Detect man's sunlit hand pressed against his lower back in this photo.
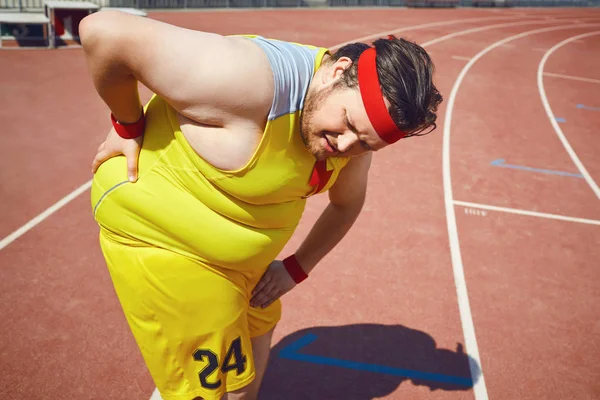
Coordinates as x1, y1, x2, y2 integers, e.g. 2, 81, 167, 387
92, 128, 144, 182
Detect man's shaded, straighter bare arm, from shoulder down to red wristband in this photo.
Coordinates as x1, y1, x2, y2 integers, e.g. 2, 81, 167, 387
296, 153, 372, 274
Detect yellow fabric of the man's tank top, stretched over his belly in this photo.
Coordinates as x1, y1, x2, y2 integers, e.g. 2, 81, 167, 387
92, 37, 348, 272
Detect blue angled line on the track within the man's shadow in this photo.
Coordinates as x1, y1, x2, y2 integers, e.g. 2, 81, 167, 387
279, 333, 473, 387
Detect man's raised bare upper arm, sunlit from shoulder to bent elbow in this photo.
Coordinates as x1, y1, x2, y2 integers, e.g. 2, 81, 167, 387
80, 11, 273, 122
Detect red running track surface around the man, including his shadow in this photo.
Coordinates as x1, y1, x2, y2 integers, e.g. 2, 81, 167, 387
0, 9, 600, 400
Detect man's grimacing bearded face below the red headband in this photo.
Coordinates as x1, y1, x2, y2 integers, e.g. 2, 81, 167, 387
300, 59, 387, 160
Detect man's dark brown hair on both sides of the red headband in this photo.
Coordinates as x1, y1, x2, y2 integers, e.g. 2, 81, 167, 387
331, 36, 443, 136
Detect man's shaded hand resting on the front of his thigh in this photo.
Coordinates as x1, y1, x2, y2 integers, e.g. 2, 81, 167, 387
250, 260, 296, 308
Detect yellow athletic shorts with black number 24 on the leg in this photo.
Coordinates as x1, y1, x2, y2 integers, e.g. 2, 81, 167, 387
100, 230, 281, 400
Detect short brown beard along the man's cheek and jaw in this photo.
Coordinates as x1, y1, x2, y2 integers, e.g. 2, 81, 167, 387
300, 87, 334, 160
